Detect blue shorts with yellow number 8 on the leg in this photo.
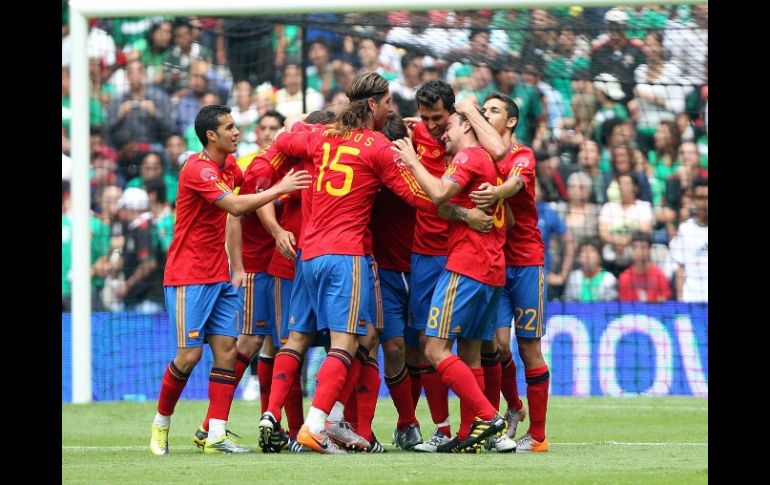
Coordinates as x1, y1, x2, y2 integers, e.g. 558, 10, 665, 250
425, 270, 503, 340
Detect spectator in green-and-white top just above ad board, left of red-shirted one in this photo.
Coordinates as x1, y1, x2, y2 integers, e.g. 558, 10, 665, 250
564, 241, 618, 302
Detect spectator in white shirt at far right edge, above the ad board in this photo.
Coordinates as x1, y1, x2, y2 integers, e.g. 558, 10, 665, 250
670, 177, 709, 302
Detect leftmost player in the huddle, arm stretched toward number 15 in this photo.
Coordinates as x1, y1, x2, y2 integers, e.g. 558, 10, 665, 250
150, 105, 311, 455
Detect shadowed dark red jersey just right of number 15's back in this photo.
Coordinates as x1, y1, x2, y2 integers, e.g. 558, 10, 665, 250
369, 187, 415, 273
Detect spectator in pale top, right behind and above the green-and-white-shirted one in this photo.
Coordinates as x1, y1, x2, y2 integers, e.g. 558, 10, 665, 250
556, 170, 600, 246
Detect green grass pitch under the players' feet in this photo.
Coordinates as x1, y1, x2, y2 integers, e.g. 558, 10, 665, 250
62, 397, 708, 485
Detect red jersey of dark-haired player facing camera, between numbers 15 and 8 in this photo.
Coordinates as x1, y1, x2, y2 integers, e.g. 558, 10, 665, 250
412, 122, 449, 255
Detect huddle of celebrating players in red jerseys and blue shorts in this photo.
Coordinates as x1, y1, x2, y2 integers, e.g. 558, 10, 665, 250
150, 73, 549, 455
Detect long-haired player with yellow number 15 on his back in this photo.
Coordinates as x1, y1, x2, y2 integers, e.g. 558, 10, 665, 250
264, 73, 476, 453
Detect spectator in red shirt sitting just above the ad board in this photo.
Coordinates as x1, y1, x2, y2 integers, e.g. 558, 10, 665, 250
618, 232, 671, 303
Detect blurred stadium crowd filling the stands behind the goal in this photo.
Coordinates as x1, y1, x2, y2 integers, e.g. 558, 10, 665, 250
62, 5, 708, 312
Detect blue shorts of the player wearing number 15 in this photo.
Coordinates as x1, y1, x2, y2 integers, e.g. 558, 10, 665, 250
304, 254, 372, 335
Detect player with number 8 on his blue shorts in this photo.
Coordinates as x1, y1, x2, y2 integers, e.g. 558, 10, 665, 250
393, 108, 505, 452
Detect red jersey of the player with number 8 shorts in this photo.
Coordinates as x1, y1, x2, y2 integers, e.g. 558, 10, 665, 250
443, 146, 505, 286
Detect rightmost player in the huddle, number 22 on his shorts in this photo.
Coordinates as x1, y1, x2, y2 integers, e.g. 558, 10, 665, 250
457, 93, 550, 453
